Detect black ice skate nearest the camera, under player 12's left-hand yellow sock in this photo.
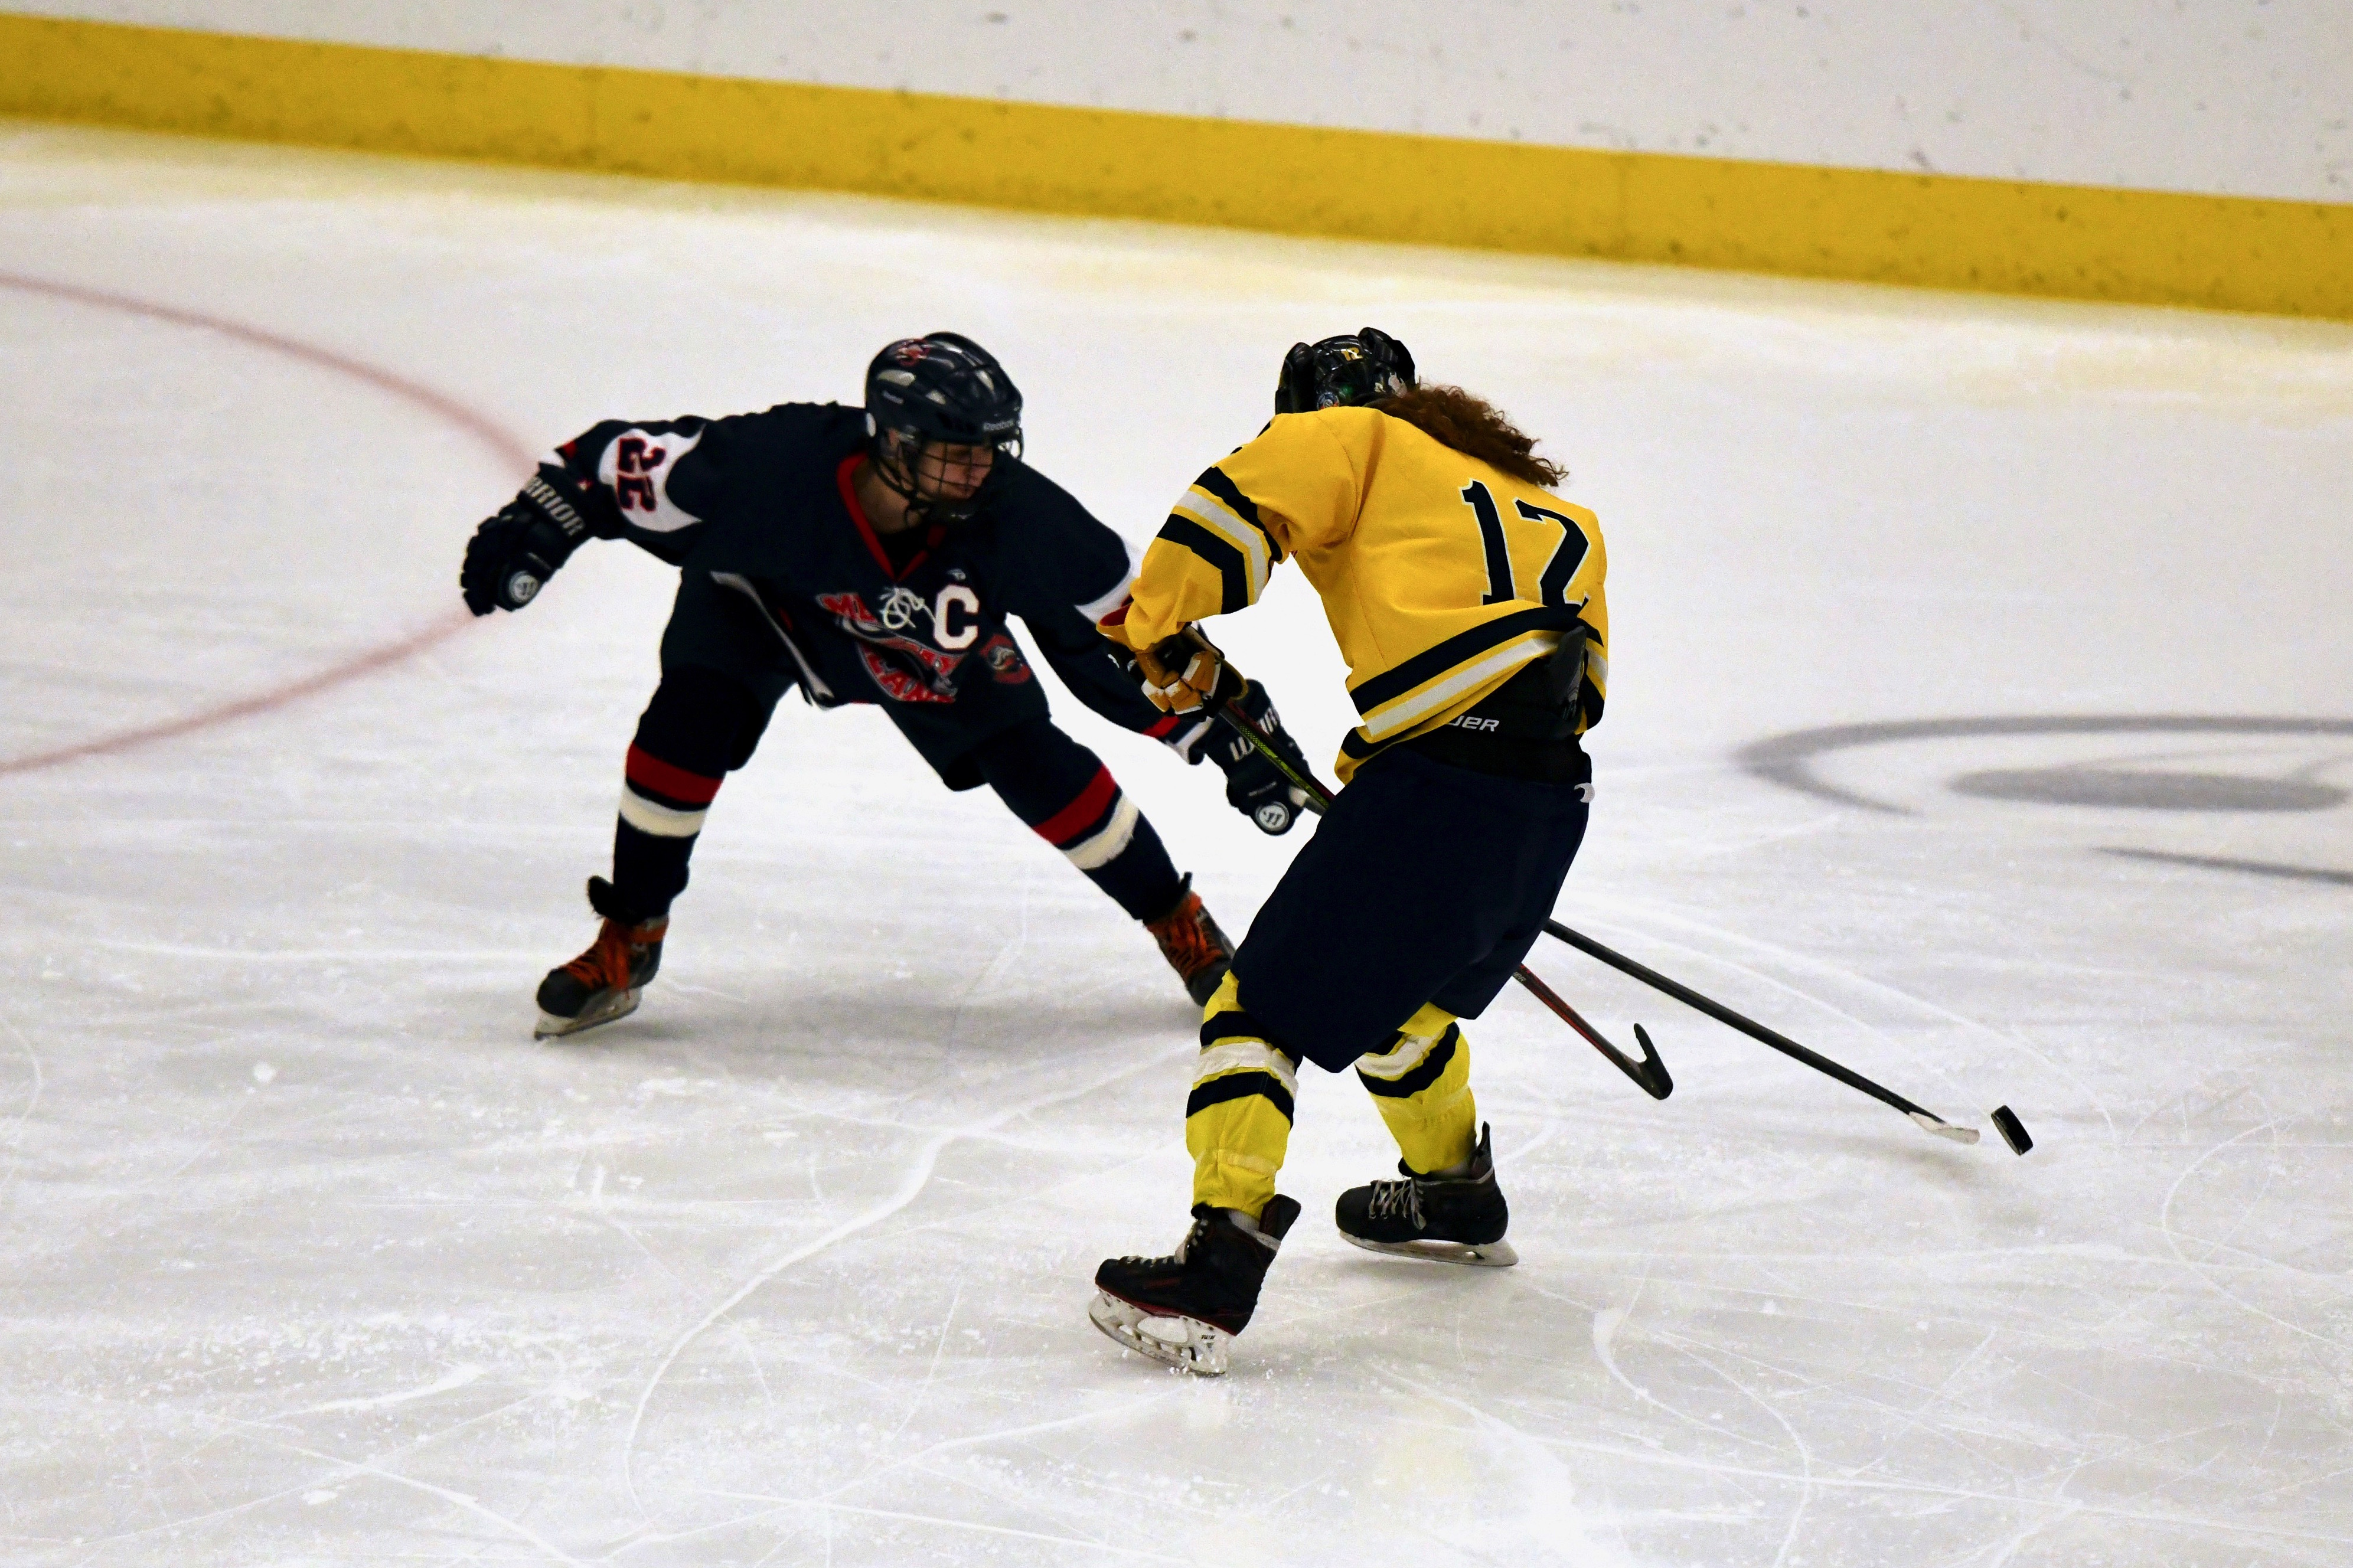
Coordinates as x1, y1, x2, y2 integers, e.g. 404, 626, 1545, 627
1087, 1196, 1299, 1377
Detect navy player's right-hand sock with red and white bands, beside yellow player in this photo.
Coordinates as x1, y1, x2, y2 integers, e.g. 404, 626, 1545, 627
972, 718, 1183, 920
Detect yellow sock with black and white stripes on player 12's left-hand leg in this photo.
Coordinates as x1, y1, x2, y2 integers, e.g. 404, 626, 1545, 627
1183, 975, 1299, 1220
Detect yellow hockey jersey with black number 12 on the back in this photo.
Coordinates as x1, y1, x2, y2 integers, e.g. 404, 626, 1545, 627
1101, 407, 1610, 782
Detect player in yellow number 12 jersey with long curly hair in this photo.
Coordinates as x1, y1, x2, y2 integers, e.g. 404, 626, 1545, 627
1089, 327, 1610, 1373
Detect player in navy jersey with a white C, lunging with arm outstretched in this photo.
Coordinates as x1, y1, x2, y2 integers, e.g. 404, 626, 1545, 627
459, 332, 1299, 1036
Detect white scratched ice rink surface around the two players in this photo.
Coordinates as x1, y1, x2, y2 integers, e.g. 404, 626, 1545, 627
0, 125, 2353, 1568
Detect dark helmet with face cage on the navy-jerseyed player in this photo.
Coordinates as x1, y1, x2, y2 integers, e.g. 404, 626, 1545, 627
866, 332, 1021, 522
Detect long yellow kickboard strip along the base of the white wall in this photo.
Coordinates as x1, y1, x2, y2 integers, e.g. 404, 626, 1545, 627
0, 17, 2353, 320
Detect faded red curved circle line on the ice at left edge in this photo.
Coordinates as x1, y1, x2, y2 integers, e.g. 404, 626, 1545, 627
0, 273, 532, 775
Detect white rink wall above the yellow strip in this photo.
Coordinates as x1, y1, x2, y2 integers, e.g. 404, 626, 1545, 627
5, 0, 2353, 202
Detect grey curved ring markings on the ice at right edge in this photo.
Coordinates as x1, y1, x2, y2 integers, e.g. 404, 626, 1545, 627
1737, 713, 2353, 885
